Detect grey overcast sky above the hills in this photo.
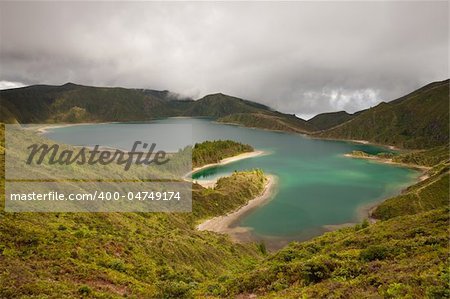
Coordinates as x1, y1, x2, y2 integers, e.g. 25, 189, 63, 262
0, 1, 449, 118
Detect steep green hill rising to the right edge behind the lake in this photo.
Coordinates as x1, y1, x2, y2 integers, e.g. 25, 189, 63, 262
316, 80, 449, 149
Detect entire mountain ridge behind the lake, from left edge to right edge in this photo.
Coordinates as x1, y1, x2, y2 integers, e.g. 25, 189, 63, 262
0, 79, 449, 149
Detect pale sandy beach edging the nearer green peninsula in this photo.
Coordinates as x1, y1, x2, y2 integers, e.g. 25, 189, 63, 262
197, 175, 277, 242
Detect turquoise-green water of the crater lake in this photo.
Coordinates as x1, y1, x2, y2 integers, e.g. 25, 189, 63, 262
46, 118, 420, 247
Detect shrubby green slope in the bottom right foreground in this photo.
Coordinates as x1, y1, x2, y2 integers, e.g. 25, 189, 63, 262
209, 208, 450, 298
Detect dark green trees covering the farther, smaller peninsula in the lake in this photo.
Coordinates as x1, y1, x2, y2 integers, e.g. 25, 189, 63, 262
192, 140, 253, 167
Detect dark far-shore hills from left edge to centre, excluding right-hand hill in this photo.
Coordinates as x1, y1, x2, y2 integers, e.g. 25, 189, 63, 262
0, 83, 313, 132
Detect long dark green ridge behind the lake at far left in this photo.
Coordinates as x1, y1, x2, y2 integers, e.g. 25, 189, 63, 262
0, 83, 172, 123
